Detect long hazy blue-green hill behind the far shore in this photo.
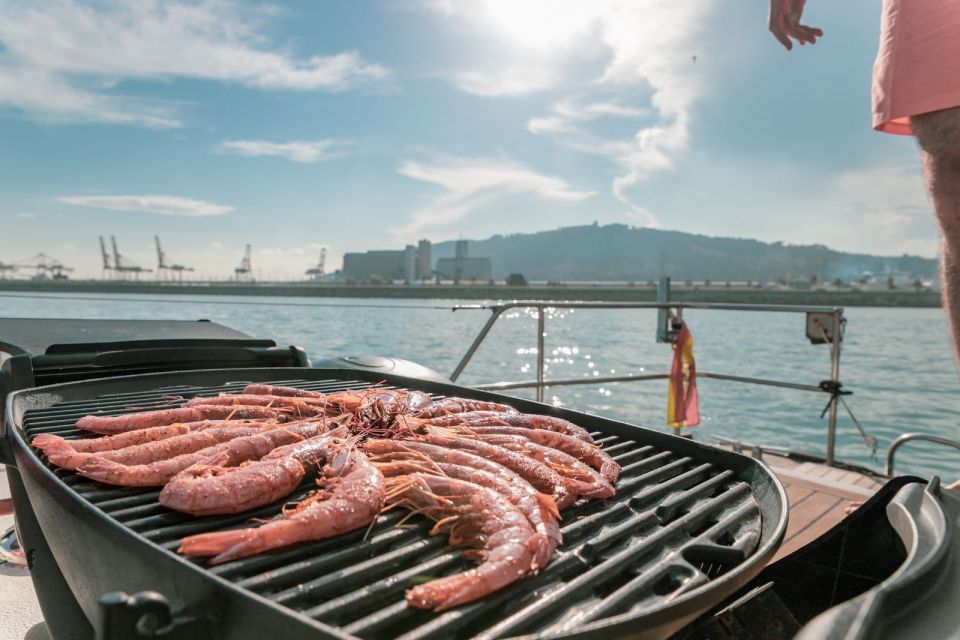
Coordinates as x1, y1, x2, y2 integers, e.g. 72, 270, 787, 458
433, 223, 937, 282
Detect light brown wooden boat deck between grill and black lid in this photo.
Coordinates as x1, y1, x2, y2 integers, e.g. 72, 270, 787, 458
763, 453, 882, 561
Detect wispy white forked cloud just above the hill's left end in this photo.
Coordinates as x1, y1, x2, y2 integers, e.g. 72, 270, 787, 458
391, 158, 595, 238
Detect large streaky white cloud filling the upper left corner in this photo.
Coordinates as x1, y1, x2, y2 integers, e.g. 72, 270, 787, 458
0, 0, 390, 127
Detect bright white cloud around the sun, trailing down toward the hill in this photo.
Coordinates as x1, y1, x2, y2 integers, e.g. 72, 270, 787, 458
432, 0, 718, 224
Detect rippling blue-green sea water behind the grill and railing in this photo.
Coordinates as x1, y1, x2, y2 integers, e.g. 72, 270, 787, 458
0, 294, 960, 481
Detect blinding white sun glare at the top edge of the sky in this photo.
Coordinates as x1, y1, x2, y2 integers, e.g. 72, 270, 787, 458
483, 0, 593, 49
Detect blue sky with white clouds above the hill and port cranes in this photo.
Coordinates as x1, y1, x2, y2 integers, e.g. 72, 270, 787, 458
0, 0, 937, 279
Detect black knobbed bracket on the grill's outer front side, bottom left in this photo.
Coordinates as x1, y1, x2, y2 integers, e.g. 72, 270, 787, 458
95, 591, 220, 640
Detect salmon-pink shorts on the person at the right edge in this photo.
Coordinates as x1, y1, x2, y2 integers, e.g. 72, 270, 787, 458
873, 0, 960, 135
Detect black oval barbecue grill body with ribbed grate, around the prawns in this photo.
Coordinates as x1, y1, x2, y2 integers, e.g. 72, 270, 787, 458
6, 369, 787, 640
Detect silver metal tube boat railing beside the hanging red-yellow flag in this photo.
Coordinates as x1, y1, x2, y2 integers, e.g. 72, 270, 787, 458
450, 300, 845, 465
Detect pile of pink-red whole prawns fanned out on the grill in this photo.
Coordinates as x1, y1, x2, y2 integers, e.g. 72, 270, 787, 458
33, 384, 620, 611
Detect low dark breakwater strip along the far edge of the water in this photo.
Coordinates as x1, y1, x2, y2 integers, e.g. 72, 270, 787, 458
0, 280, 941, 307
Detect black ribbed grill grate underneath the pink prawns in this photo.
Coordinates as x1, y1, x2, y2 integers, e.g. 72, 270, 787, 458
15, 379, 761, 640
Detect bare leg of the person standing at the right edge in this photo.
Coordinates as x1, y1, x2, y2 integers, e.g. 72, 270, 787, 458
910, 108, 960, 368
